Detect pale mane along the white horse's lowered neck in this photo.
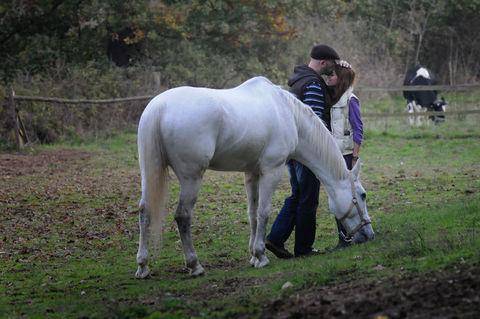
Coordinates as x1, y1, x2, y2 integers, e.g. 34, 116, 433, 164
274, 86, 348, 179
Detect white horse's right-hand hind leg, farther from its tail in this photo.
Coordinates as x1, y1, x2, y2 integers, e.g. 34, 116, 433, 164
175, 175, 205, 276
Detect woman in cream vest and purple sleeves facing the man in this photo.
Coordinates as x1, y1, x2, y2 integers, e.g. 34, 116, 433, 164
325, 64, 363, 249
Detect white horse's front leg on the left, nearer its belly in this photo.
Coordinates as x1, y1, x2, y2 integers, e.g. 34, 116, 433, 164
245, 173, 258, 266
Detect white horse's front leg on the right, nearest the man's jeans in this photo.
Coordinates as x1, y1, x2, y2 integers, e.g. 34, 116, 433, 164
253, 166, 283, 268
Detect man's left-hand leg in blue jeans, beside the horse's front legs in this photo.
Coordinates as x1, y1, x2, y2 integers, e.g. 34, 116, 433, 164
267, 161, 298, 258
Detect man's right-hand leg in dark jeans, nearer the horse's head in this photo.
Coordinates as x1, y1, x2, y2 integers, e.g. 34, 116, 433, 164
295, 163, 320, 256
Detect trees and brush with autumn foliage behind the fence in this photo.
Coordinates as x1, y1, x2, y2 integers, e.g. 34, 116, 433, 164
0, 0, 480, 146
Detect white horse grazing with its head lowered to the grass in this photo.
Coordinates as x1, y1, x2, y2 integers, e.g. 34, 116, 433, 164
136, 77, 374, 278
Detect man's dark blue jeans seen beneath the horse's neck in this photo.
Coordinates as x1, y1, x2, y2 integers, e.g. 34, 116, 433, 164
267, 160, 320, 256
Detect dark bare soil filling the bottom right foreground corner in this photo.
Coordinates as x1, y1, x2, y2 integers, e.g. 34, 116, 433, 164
261, 265, 480, 319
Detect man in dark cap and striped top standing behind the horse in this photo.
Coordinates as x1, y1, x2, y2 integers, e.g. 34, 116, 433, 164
265, 44, 340, 258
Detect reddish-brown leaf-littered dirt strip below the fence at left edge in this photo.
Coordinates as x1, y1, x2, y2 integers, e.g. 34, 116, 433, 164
0, 150, 91, 178
